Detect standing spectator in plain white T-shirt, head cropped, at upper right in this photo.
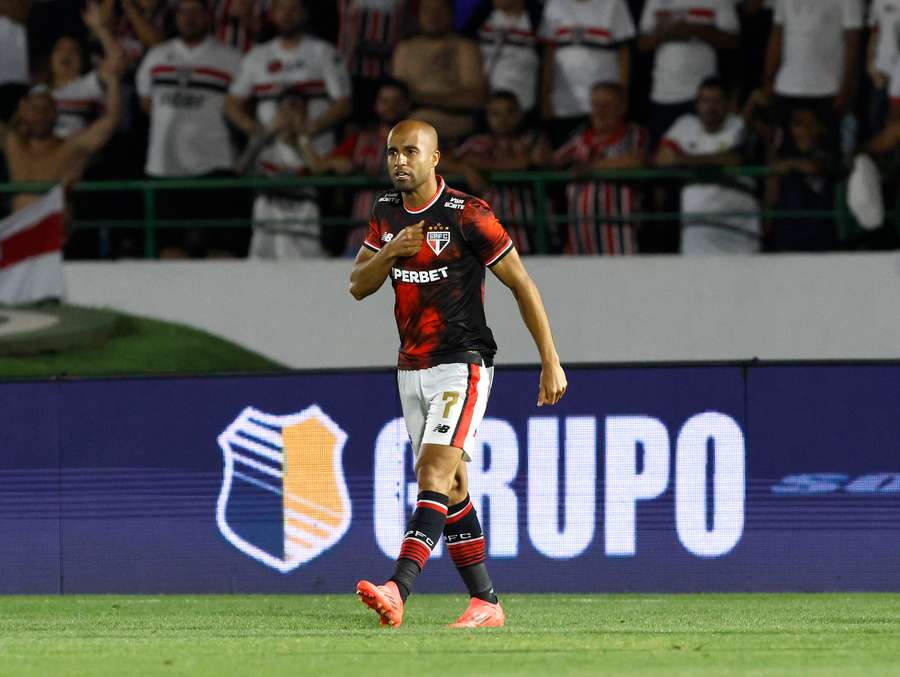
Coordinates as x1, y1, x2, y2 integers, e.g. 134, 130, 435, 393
765, 0, 863, 134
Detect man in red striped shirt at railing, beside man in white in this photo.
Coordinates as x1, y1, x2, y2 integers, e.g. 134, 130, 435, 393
554, 82, 649, 254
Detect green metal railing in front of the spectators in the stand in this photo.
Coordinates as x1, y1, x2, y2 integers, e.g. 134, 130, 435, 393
0, 166, 872, 258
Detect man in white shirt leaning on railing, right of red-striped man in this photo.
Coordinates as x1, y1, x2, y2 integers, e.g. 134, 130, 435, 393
656, 78, 760, 255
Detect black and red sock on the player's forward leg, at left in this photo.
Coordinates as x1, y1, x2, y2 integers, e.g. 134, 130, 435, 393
390, 491, 450, 602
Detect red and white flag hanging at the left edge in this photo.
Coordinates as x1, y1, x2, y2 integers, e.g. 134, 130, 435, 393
0, 186, 66, 306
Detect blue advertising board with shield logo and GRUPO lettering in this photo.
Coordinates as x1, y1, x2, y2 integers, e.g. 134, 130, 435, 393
0, 366, 900, 593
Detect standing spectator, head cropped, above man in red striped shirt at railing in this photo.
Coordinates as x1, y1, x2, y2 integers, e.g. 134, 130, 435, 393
540, 0, 635, 146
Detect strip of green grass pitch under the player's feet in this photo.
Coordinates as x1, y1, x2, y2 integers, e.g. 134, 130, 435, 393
0, 594, 900, 677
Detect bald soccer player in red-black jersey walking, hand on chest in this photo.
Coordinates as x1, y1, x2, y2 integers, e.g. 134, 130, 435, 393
350, 120, 566, 628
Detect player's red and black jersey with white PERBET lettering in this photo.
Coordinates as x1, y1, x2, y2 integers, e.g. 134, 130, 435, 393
363, 177, 513, 369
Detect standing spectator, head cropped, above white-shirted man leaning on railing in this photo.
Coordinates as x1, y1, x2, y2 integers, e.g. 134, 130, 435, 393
638, 0, 740, 147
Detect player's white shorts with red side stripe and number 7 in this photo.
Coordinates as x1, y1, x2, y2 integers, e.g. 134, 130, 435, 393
397, 362, 494, 461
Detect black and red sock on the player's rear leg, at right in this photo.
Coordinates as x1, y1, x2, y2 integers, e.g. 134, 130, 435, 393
444, 495, 497, 604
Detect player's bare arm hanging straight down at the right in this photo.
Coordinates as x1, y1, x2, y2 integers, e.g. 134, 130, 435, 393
491, 249, 568, 407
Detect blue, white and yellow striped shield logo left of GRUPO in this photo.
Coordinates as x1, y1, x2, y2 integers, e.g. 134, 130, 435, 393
216, 405, 351, 574
